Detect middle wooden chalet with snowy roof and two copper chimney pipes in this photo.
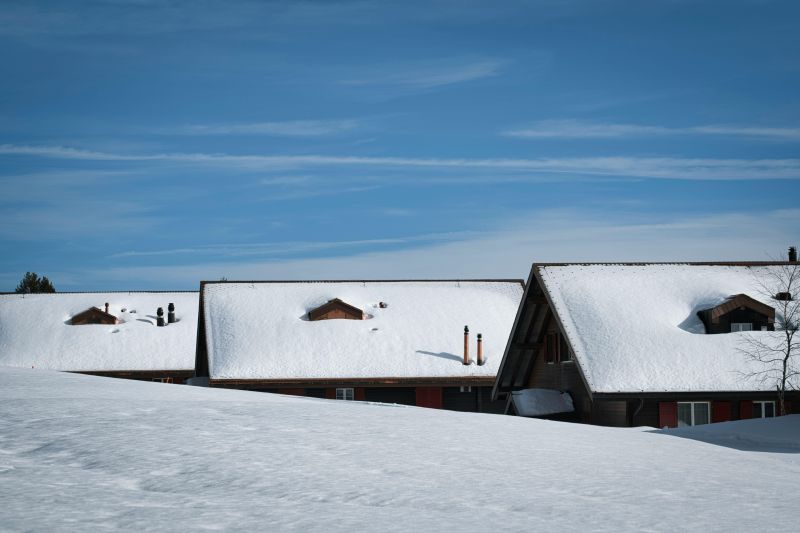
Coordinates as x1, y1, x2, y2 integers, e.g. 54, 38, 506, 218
196, 280, 523, 412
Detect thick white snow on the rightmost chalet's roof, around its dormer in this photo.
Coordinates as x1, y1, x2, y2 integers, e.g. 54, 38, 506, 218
539, 264, 782, 392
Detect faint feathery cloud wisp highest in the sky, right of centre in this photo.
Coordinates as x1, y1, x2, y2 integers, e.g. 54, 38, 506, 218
341, 59, 509, 90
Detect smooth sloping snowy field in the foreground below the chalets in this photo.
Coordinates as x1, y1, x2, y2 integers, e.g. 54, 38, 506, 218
0, 368, 800, 532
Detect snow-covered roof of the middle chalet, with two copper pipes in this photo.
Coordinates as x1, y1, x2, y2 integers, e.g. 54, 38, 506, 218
203, 281, 523, 380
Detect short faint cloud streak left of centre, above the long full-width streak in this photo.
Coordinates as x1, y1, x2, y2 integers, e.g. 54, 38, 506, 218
170, 119, 360, 137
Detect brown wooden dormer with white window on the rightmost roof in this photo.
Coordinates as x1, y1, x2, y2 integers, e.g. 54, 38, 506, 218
697, 294, 775, 333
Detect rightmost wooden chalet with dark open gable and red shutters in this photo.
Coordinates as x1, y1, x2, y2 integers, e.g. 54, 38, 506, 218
492, 262, 800, 427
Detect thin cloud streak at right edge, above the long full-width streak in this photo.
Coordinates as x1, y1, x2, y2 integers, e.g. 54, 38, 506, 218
503, 119, 800, 141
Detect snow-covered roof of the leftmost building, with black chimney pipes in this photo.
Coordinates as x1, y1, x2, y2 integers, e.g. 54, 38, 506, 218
0, 292, 198, 371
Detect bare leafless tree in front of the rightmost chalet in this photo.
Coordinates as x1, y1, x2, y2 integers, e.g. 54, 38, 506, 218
741, 261, 800, 415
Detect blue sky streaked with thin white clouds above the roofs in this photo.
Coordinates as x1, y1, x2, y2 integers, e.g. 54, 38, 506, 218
0, 0, 800, 290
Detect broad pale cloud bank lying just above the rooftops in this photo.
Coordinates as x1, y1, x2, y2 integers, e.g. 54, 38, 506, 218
69, 209, 800, 289
